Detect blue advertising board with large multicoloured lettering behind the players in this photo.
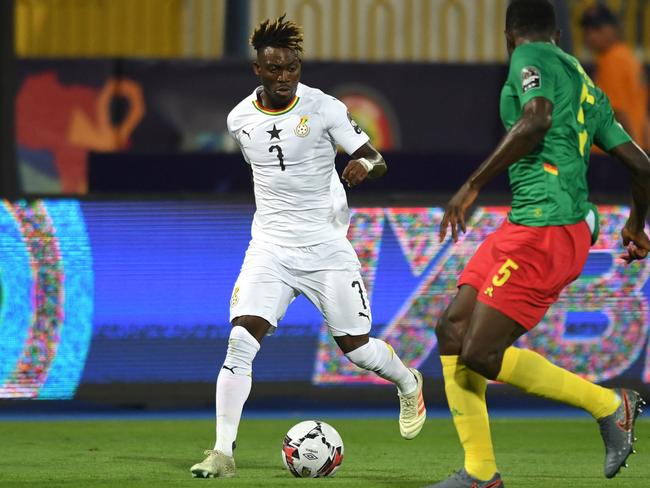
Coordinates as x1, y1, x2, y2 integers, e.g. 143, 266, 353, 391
0, 200, 650, 398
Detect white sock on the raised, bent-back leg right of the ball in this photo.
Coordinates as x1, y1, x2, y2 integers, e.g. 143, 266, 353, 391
346, 337, 418, 395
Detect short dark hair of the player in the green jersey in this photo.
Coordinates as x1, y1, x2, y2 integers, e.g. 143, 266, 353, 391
506, 0, 557, 35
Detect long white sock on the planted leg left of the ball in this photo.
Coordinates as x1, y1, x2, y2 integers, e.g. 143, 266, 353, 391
214, 326, 260, 456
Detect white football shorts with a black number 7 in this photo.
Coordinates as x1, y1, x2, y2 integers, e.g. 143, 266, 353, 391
230, 238, 372, 336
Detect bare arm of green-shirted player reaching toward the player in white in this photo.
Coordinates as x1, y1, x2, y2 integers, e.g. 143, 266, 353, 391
439, 97, 553, 242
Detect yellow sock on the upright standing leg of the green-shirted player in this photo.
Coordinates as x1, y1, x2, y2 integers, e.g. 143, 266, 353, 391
440, 356, 497, 480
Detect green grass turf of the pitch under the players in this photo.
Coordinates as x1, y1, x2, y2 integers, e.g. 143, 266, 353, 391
0, 419, 650, 488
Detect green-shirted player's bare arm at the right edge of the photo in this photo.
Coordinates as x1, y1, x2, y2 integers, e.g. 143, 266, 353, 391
609, 142, 650, 263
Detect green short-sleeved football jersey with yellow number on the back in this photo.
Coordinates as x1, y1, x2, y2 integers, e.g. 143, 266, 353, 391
500, 42, 630, 227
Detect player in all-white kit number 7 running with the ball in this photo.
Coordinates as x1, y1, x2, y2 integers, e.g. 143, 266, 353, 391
191, 16, 426, 478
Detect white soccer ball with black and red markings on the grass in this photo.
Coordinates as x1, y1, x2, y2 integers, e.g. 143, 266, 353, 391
282, 420, 343, 478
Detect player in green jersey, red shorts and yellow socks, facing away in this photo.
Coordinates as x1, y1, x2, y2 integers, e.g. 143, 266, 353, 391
433, 0, 650, 488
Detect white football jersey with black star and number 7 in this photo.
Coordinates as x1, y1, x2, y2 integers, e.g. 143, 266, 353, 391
228, 83, 369, 247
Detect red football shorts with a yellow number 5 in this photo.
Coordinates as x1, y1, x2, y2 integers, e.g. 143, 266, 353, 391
458, 220, 591, 330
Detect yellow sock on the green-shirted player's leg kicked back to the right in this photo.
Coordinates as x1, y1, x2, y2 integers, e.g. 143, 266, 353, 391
496, 347, 621, 419
